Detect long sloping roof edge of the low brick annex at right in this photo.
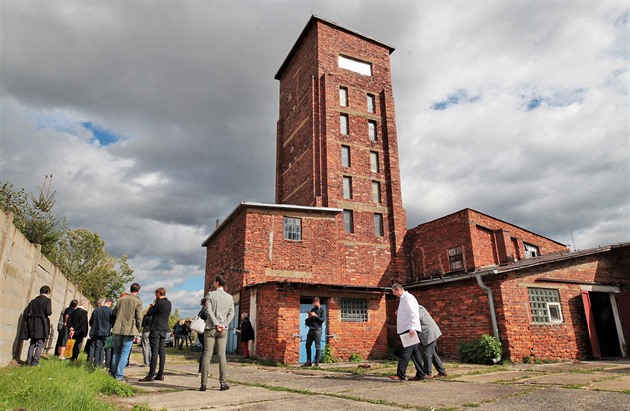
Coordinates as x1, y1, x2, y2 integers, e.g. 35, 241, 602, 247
405, 242, 630, 289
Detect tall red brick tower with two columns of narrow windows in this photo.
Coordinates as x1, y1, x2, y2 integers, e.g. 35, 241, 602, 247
275, 15, 407, 280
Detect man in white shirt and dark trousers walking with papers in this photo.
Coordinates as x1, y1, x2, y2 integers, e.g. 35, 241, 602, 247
389, 283, 426, 381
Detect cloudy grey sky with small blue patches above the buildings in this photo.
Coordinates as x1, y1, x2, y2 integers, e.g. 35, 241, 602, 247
0, 0, 630, 315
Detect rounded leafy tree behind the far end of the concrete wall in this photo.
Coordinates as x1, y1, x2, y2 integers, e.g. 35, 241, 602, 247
51, 228, 133, 303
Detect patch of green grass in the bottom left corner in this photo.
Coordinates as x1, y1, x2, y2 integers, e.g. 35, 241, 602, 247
0, 355, 135, 411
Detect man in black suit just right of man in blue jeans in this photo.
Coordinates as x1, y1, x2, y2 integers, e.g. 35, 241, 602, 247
140, 287, 171, 382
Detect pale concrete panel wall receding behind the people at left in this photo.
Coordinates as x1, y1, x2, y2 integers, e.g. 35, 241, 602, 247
0, 210, 91, 366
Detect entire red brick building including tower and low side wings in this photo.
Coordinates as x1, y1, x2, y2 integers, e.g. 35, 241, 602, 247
203, 16, 630, 364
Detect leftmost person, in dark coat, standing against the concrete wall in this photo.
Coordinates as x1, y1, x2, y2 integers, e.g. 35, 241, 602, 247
24, 285, 52, 366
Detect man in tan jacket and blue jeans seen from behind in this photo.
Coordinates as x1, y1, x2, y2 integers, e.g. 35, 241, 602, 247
109, 283, 142, 380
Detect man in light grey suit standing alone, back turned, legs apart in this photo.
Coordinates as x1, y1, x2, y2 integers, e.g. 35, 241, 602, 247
199, 275, 234, 391
